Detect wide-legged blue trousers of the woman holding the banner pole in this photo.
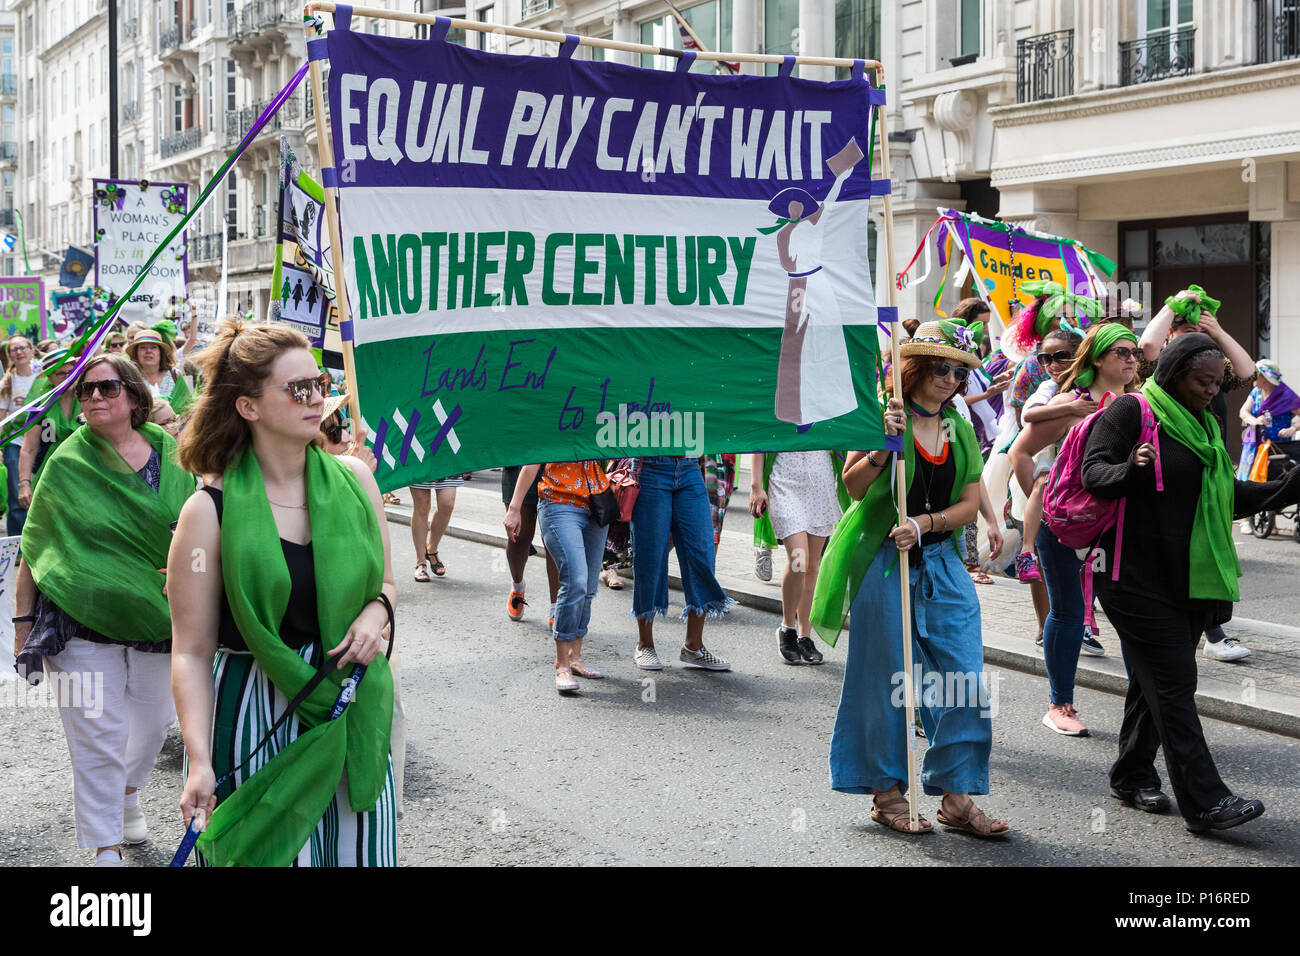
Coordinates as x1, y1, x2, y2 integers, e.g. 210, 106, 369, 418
831, 538, 995, 796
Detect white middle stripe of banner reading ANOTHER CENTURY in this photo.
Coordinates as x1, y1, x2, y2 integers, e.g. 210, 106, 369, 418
342, 187, 876, 345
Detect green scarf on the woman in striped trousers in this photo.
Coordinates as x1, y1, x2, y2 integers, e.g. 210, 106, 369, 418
198, 446, 393, 866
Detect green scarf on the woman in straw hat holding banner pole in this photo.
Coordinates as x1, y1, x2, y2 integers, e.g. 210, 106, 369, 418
811, 406, 984, 648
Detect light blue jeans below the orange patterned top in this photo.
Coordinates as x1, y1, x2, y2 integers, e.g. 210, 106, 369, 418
537, 498, 610, 641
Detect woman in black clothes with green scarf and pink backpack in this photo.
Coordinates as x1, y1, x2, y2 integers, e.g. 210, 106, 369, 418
1083, 333, 1300, 832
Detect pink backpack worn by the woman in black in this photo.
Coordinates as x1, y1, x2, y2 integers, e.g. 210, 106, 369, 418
1043, 392, 1165, 587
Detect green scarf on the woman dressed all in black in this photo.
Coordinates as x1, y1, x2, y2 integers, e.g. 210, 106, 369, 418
1143, 378, 1242, 601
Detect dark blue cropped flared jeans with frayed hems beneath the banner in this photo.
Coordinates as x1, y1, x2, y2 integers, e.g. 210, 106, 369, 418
632, 455, 736, 620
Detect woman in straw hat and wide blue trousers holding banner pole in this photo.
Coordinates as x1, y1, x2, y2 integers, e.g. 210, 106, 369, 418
813, 321, 1010, 836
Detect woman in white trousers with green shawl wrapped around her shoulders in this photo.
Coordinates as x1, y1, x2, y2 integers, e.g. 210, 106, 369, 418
14, 355, 194, 866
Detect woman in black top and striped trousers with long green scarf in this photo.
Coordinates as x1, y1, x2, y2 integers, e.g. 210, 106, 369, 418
170, 320, 397, 866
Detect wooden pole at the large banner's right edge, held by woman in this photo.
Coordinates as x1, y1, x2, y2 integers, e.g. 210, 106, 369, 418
876, 66, 920, 832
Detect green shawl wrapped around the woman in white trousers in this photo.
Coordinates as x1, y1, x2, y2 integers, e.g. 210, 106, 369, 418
22, 421, 194, 643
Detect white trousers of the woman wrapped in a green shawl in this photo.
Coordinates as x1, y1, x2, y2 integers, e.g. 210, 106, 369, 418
46, 637, 176, 848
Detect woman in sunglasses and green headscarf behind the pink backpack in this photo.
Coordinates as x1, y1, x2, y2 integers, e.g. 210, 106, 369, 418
1010, 321, 1141, 737
